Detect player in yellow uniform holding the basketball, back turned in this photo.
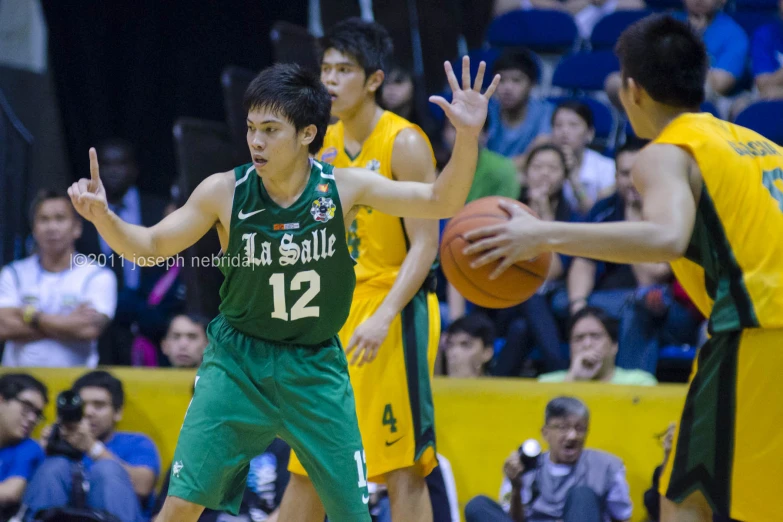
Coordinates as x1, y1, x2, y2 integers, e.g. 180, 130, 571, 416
466, 16, 783, 522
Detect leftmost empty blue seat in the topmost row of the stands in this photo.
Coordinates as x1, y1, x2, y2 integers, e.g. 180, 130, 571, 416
486, 9, 578, 53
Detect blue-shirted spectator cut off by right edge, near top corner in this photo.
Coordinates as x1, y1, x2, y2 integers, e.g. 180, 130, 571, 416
751, 0, 783, 100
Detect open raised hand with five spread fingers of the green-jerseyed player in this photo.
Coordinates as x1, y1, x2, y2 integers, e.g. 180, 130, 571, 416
430, 56, 500, 136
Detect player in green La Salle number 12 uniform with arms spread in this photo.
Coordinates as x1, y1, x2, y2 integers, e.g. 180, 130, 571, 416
68, 57, 500, 522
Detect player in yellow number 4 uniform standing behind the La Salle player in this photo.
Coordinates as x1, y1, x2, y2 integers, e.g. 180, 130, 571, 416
286, 18, 440, 522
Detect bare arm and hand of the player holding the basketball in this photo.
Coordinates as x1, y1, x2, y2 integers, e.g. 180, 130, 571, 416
465, 144, 696, 275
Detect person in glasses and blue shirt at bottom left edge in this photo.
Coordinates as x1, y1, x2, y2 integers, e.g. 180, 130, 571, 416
0, 373, 49, 520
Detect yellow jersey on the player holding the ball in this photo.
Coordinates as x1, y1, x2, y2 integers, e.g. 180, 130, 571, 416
655, 113, 783, 334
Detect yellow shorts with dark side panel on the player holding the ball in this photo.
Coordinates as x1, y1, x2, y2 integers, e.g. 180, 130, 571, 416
659, 329, 783, 522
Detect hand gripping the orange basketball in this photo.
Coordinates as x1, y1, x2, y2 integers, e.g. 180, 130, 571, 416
463, 201, 544, 279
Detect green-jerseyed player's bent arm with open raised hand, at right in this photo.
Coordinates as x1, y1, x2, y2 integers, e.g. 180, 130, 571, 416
335, 56, 500, 219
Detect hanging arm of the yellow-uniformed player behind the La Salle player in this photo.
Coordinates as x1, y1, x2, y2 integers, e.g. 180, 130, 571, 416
346, 129, 439, 366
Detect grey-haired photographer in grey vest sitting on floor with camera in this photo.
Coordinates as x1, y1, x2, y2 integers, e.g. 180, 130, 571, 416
465, 397, 633, 522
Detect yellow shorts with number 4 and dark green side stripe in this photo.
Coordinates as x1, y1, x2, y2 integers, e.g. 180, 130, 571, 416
288, 290, 440, 484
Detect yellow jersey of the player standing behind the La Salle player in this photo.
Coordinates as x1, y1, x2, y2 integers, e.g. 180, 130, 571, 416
316, 111, 435, 291
